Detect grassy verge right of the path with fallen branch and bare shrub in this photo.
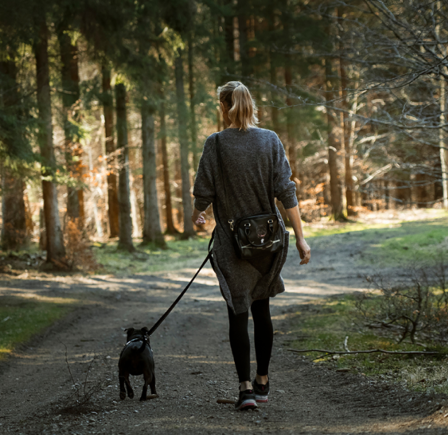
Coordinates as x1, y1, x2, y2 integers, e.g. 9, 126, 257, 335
288, 295, 448, 393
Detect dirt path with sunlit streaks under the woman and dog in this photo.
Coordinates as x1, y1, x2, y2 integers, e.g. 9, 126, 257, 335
0, 212, 448, 434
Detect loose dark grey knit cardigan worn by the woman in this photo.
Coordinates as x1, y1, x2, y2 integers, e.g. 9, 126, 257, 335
193, 128, 297, 314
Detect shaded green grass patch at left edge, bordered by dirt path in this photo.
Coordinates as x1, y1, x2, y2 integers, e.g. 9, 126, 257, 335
0, 296, 76, 360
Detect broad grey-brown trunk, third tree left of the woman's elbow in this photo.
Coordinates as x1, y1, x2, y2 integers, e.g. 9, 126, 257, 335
141, 103, 166, 247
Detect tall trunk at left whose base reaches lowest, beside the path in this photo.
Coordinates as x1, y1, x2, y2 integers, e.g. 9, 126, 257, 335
34, 17, 66, 268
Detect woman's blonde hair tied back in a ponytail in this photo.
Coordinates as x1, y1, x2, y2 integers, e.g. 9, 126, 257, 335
218, 82, 258, 131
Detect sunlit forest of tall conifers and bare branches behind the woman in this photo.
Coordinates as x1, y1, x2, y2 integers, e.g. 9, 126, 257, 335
0, 0, 448, 268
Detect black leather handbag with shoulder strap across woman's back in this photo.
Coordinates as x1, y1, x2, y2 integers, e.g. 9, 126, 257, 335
216, 133, 285, 260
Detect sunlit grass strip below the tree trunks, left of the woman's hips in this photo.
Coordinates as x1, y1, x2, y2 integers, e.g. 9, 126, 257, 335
93, 237, 210, 275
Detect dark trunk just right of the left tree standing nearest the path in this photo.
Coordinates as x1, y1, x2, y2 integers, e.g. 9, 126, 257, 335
58, 27, 84, 228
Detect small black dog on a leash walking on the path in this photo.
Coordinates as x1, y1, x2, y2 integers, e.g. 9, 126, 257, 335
118, 327, 157, 400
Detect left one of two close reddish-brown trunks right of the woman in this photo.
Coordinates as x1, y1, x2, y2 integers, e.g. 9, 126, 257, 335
325, 58, 345, 220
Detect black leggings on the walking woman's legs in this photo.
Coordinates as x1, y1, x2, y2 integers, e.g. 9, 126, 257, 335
227, 298, 274, 382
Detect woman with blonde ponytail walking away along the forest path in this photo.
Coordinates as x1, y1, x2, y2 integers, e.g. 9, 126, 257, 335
192, 81, 311, 410
